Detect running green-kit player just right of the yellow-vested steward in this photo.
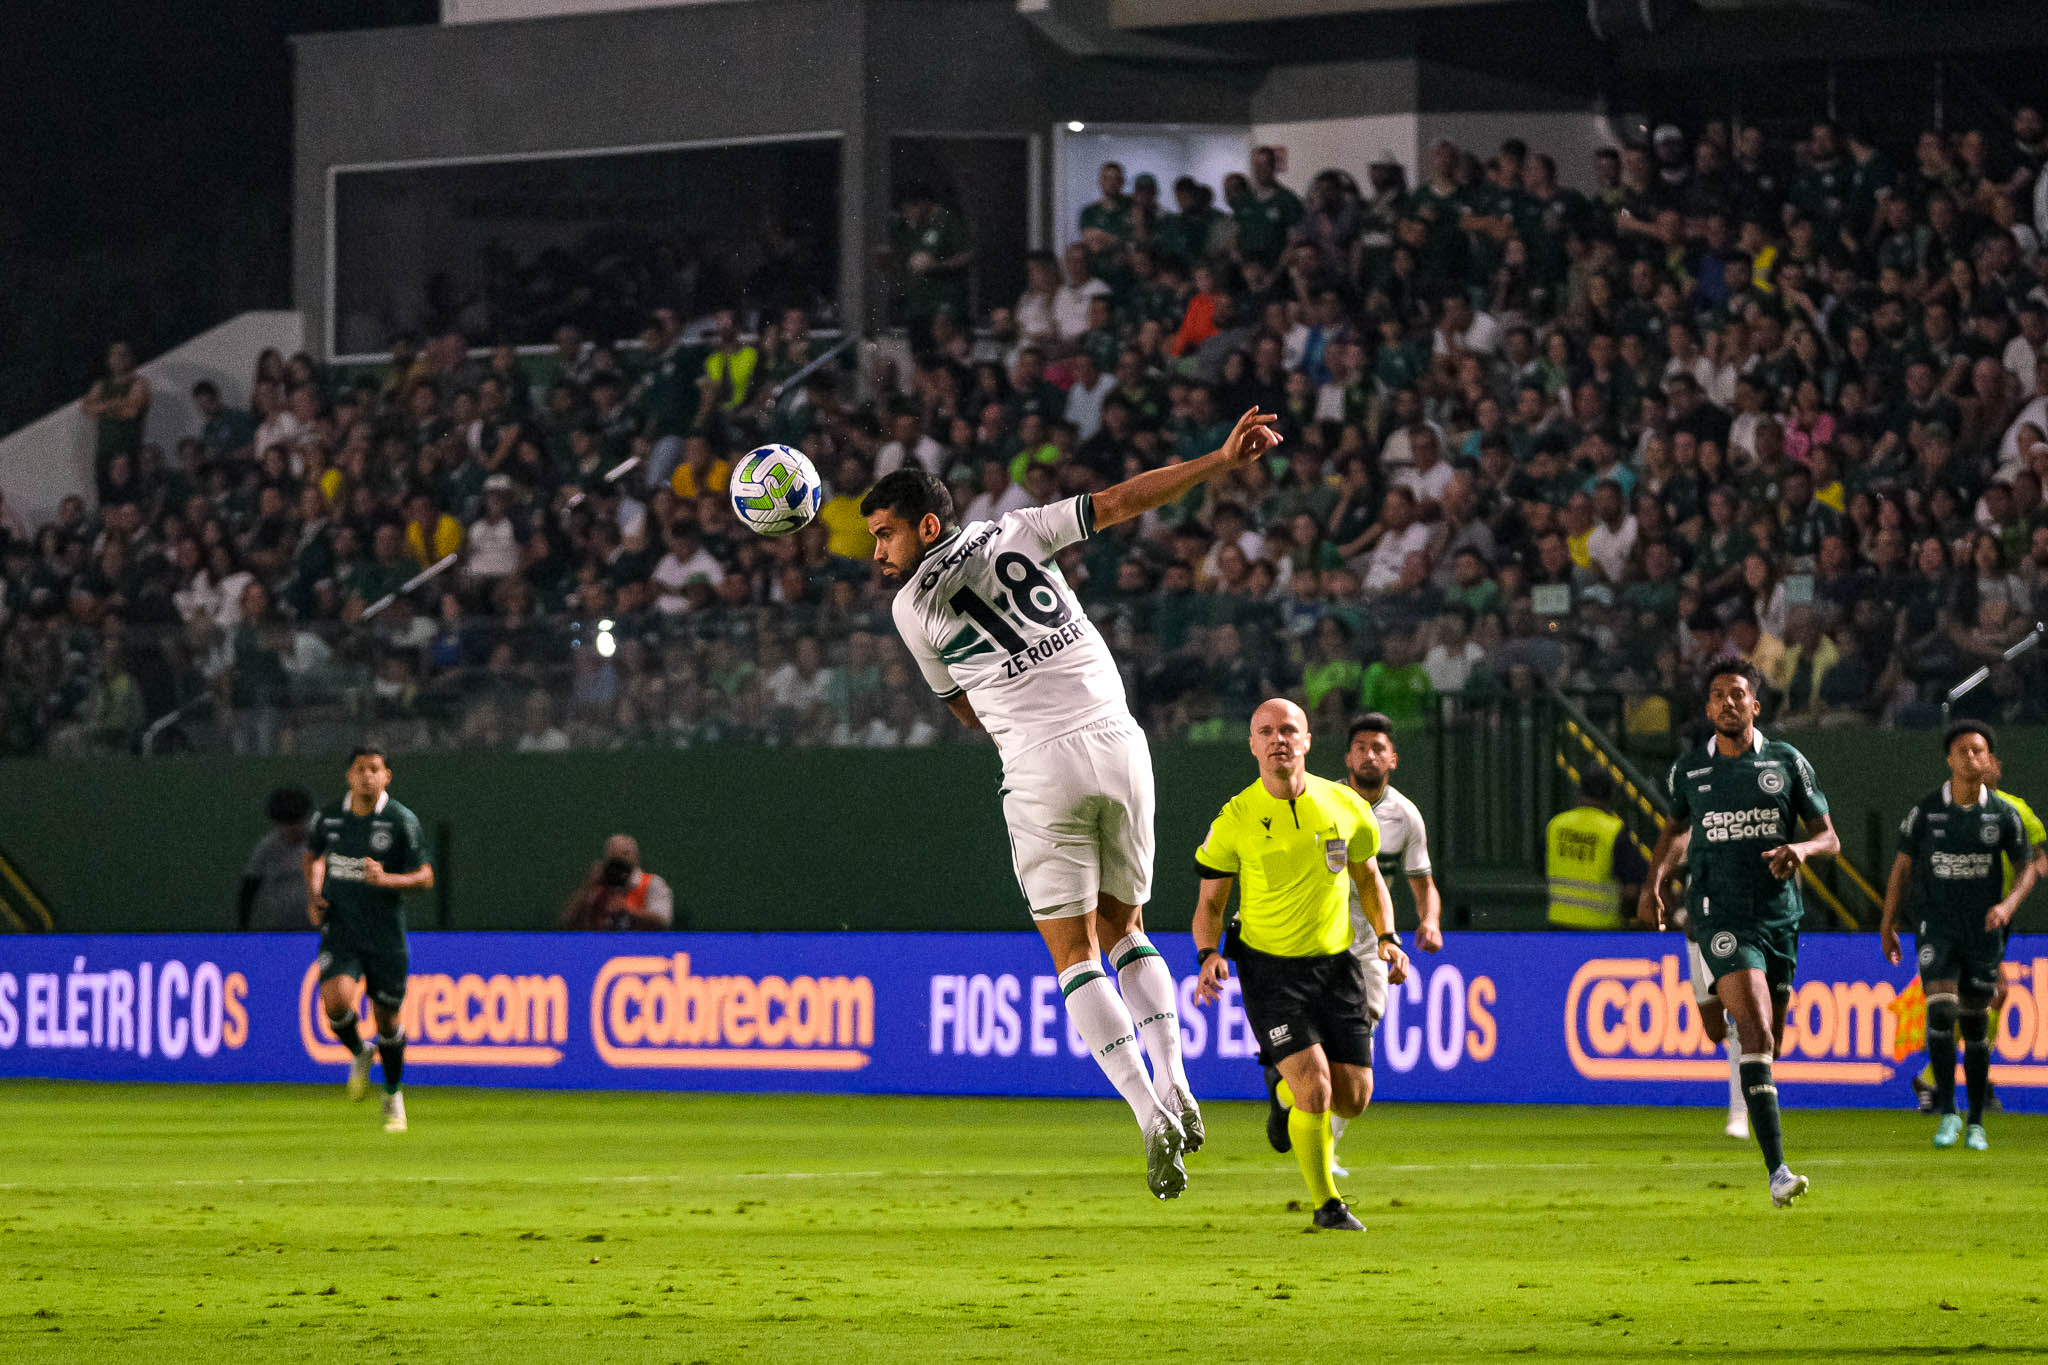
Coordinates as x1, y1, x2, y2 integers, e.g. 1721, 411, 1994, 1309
1638, 659, 1841, 1207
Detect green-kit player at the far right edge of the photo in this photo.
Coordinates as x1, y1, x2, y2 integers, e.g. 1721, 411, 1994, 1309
1880, 720, 2040, 1152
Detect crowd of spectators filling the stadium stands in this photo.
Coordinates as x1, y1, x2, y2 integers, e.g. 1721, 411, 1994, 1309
12, 108, 2048, 753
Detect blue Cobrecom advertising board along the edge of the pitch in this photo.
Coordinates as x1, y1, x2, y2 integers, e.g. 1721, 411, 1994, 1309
0, 933, 2048, 1109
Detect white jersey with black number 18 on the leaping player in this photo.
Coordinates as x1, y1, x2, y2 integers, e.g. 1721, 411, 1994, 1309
893, 493, 1130, 763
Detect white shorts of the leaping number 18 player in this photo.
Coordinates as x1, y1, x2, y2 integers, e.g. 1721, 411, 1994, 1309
1004, 716, 1153, 919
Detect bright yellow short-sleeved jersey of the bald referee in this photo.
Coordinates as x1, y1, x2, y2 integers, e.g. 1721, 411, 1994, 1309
1194, 774, 1380, 958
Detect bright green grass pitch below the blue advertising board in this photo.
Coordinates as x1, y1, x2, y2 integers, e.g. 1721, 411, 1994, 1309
0, 1083, 2048, 1365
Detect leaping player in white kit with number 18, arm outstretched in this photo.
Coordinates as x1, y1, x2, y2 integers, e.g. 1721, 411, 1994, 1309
860, 409, 1280, 1199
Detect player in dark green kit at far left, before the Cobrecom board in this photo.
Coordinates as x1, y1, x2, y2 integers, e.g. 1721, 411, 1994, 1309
305, 749, 434, 1134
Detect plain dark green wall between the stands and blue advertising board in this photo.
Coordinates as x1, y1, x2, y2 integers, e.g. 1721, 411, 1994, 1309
12, 714, 2048, 931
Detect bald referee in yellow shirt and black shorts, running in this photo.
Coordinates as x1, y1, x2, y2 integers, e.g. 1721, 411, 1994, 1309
1194, 698, 1407, 1232
